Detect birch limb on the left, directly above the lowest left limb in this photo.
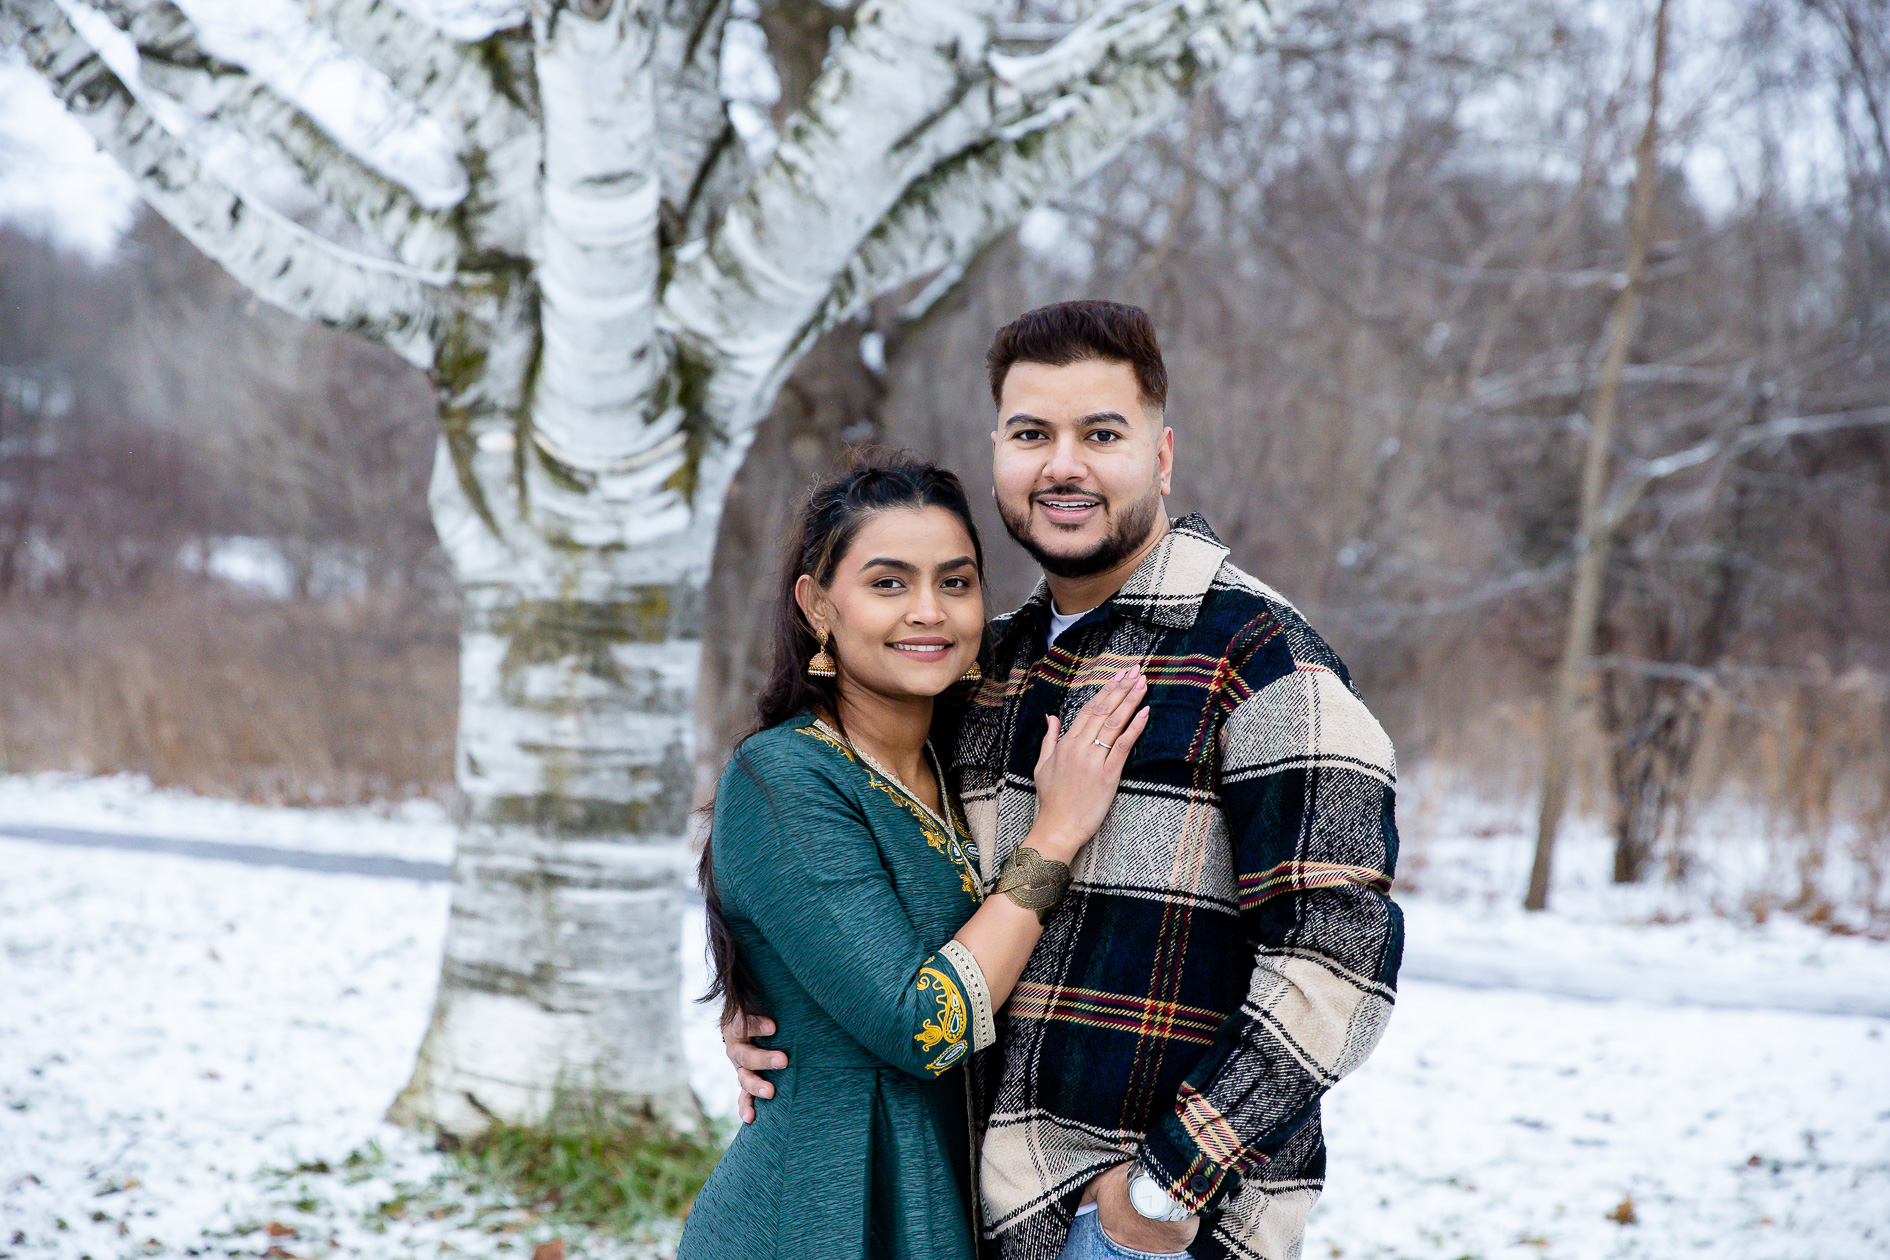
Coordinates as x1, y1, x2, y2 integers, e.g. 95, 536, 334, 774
85, 0, 459, 270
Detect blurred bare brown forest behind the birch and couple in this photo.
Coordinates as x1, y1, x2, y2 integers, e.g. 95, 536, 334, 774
0, 0, 1890, 924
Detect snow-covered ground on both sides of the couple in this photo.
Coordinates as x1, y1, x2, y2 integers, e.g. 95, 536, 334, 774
0, 778, 1890, 1260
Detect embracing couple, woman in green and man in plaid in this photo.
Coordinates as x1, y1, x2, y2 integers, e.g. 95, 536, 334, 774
679, 302, 1402, 1260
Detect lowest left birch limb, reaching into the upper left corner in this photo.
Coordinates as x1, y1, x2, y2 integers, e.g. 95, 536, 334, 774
0, 0, 452, 363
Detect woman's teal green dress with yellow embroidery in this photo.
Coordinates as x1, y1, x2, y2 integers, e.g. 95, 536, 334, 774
677, 714, 996, 1260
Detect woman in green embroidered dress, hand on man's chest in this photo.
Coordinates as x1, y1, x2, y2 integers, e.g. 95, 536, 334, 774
677, 453, 1147, 1260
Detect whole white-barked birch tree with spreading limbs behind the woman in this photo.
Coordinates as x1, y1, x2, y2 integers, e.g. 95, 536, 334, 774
0, 0, 1287, 1135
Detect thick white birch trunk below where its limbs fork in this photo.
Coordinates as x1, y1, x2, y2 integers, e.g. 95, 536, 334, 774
389, 313, 721, 1137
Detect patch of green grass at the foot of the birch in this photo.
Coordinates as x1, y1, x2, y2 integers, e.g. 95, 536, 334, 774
454, 1107, 726, 1234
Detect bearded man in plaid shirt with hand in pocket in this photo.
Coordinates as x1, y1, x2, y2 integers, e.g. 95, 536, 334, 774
730, 302, 1402, 1260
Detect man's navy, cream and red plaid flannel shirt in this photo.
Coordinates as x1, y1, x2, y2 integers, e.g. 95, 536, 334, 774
954, 516, 1404, 1260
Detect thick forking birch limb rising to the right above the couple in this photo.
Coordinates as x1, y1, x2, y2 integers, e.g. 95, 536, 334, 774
665, 0, 1280, 423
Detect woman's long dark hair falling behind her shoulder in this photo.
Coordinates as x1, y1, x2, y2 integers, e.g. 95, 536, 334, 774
696, 448, 985, 1022
